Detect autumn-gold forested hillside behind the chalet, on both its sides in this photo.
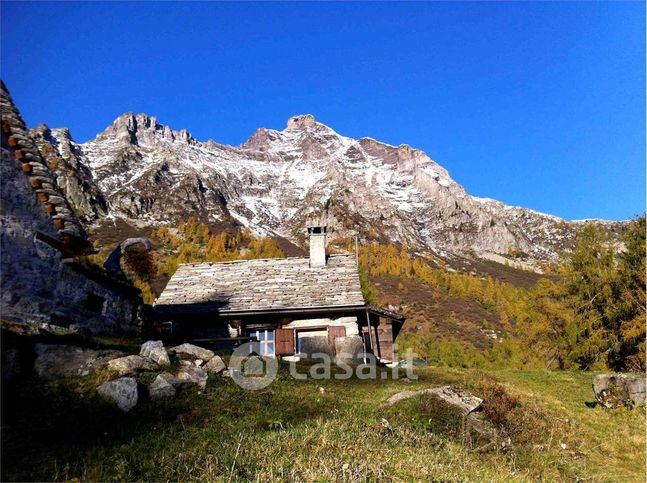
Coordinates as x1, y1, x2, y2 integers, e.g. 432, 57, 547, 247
88, 217, 645, 371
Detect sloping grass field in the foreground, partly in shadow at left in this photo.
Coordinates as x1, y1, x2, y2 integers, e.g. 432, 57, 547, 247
2, 368, 645, 481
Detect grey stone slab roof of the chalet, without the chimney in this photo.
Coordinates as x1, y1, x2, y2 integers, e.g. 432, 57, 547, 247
155, 255, 365, 314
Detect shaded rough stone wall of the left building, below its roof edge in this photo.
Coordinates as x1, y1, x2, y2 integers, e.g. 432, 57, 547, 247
0, 149, 138, 333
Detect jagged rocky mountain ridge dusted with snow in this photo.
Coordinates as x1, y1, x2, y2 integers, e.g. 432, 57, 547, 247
32, 113, 624, 261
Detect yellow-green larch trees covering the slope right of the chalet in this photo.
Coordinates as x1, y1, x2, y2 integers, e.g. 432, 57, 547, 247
360, 217, 645, 371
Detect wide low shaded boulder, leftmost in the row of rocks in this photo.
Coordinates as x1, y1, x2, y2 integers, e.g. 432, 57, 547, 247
34, 344, 123, 379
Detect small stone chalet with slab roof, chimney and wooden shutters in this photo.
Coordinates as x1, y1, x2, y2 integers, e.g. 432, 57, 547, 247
155, 227, 404, 362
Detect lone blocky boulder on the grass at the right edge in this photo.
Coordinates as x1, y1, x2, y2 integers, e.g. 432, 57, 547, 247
593, 373, 645, 408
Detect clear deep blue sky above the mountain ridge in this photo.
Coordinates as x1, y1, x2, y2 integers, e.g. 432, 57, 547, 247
1, 2, 645, 219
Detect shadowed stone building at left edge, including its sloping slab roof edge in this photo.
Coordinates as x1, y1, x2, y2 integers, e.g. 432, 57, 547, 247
0, 83, 141, 333
